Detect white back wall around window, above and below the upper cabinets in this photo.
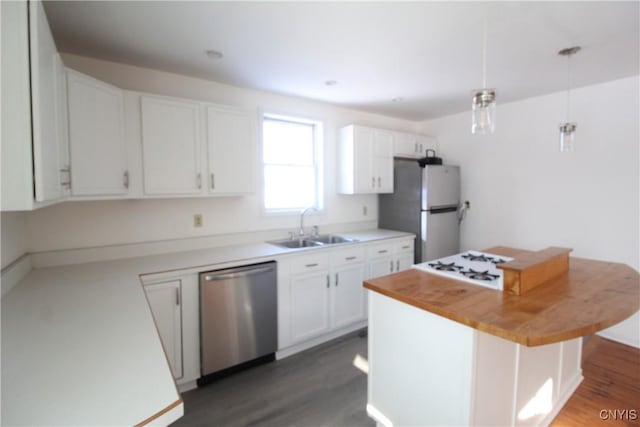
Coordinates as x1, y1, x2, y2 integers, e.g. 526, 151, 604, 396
22, 55, 416, 252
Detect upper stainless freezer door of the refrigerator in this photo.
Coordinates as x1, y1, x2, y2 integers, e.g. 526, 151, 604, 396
422, 165, 460, 210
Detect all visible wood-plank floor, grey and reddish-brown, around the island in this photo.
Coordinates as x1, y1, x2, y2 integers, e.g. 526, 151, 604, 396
173, 333, 640, 427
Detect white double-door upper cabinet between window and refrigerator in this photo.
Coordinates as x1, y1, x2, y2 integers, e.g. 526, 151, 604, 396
338, 125, 393, 194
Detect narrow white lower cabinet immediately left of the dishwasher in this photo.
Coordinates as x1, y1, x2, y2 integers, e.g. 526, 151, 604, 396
143, 273, 200, 390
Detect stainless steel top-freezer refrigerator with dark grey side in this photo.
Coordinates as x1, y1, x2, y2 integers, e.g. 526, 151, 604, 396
378, 158, 460, 263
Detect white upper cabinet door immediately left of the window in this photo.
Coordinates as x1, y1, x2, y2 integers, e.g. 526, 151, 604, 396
207, 107, 257, 194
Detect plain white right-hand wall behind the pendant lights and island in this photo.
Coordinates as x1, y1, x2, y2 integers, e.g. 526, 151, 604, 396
420, 76, 640, 346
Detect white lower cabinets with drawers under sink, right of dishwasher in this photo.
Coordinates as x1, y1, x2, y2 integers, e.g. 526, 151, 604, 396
278, 237, 413, 356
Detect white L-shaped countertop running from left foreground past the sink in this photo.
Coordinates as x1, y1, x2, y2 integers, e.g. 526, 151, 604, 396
1, 230, 410, 425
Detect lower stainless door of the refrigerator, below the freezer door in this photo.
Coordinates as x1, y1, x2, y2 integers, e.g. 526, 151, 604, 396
420, 207, 460, 262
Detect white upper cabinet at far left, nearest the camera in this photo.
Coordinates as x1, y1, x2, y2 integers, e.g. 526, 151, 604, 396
1, 1, 67, 210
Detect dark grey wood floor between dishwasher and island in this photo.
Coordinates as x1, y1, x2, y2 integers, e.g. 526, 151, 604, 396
172, 333, 375, 427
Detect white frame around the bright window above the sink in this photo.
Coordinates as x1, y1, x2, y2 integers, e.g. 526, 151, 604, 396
258, 110, 325, 216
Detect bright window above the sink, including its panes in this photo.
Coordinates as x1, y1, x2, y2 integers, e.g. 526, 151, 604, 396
262, 115, 322, 212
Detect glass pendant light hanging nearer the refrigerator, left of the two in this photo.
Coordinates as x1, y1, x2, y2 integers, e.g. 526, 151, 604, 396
471, 17, 496, 134
